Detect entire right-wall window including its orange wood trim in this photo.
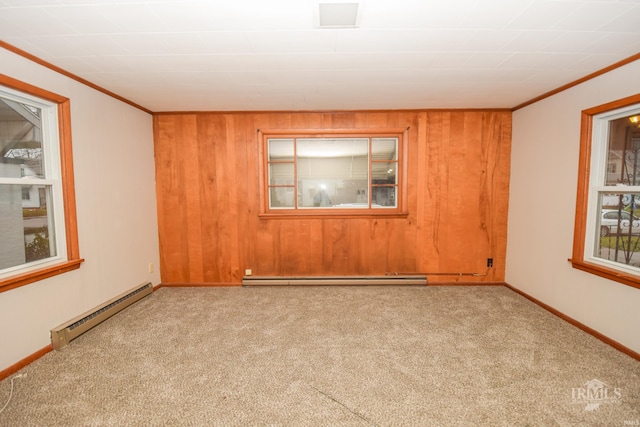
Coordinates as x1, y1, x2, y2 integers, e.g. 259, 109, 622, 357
571, 95, 640, 288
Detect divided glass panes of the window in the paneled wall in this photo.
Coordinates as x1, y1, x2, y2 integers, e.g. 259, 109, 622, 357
263, 133, 402, 214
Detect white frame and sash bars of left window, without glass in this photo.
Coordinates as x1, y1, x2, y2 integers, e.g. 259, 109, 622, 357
0, 86, 67, 279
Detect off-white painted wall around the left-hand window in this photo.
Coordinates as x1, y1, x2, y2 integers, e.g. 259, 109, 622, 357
0, 49, 160, 370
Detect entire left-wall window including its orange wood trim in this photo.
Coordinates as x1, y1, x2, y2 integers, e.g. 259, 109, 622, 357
0, 75, 82, 292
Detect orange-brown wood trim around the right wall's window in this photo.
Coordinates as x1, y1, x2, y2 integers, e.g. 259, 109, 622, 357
569, 94, 640, 289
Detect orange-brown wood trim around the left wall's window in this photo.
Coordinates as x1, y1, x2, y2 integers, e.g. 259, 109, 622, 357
0, 74, 84, 292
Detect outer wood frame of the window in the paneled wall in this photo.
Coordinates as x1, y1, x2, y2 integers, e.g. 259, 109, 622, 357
258, 127, 409, 219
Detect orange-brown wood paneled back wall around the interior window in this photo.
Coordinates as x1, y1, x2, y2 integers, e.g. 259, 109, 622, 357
154, 110, 511, 285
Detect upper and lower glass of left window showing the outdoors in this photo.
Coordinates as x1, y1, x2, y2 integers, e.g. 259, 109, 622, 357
0, 96, 55, 271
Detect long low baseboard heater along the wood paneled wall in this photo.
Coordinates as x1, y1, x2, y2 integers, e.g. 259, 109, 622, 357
242, 275, 427, 286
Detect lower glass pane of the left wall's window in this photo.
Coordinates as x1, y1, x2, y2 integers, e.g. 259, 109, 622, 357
0, 184, 56, 269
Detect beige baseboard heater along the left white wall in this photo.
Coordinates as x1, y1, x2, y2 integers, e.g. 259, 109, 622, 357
51, 283, 153, 350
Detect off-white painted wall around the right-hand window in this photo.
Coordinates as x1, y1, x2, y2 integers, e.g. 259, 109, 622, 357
506, 61, 640, 352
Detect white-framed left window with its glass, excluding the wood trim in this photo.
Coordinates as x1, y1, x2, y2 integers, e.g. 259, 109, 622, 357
0, 86, 67, 281
